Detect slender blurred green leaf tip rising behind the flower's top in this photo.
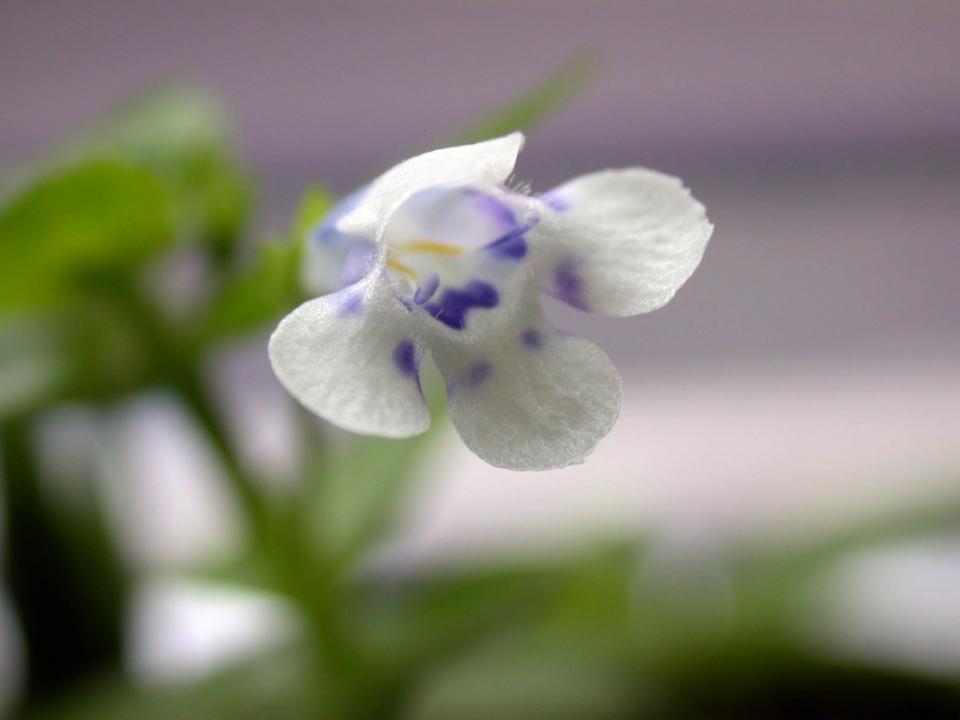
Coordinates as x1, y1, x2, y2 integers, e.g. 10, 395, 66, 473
455, 54, 598, 143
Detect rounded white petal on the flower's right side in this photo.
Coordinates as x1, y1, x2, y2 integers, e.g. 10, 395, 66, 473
531, 168, 713, 317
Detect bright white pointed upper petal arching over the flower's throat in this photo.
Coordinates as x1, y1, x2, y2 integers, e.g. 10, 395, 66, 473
337, 132, 523, 238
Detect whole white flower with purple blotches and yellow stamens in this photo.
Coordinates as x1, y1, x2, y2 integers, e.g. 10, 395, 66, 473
270, 133, 713, 470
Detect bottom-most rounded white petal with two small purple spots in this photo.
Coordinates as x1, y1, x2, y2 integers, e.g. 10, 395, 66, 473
432, 308, 623, 470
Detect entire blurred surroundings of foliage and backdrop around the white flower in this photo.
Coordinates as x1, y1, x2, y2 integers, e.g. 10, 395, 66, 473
0, 0, 960, 718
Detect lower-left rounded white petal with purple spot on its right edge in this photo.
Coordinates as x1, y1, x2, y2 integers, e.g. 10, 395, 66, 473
269, 268, 430, 438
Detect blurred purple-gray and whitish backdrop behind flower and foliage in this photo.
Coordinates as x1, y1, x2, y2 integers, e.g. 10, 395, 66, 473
0, 0, 960, 692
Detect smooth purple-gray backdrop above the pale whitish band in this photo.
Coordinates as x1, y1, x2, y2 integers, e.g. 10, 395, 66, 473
0, 0, 960, 367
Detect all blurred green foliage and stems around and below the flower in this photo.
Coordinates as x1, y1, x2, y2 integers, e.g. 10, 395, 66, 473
9, 56, 960, 720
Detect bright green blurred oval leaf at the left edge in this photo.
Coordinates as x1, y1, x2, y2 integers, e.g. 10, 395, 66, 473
0, 160, 171, 312
